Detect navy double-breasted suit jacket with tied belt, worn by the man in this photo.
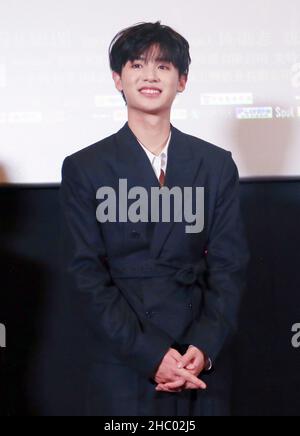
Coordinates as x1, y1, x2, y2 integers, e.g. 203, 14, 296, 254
60, 123, 249, 416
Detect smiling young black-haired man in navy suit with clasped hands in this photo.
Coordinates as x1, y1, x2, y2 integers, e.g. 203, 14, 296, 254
60, 22, 249, 416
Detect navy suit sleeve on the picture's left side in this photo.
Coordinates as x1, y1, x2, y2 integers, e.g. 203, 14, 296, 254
59, 156, 174, 378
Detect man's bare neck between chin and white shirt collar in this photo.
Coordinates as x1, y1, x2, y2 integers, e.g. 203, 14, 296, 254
128, 111, 171, 155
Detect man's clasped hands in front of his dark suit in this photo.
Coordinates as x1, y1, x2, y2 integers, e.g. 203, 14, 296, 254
154, 347, 207, 392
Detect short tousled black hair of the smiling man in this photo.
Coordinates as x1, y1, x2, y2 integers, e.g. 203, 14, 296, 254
109, 21, 191, 102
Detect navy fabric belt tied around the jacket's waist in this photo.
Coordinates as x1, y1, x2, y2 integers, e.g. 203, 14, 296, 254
107, 257, 206, 288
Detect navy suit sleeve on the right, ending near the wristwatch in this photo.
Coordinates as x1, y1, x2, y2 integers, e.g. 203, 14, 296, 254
185, 152, 250, 361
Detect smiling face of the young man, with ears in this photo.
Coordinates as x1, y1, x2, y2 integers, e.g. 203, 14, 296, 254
113, 46, 187, 114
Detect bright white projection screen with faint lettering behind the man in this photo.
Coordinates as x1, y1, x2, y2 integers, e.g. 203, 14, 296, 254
0, 0, 300, 183
